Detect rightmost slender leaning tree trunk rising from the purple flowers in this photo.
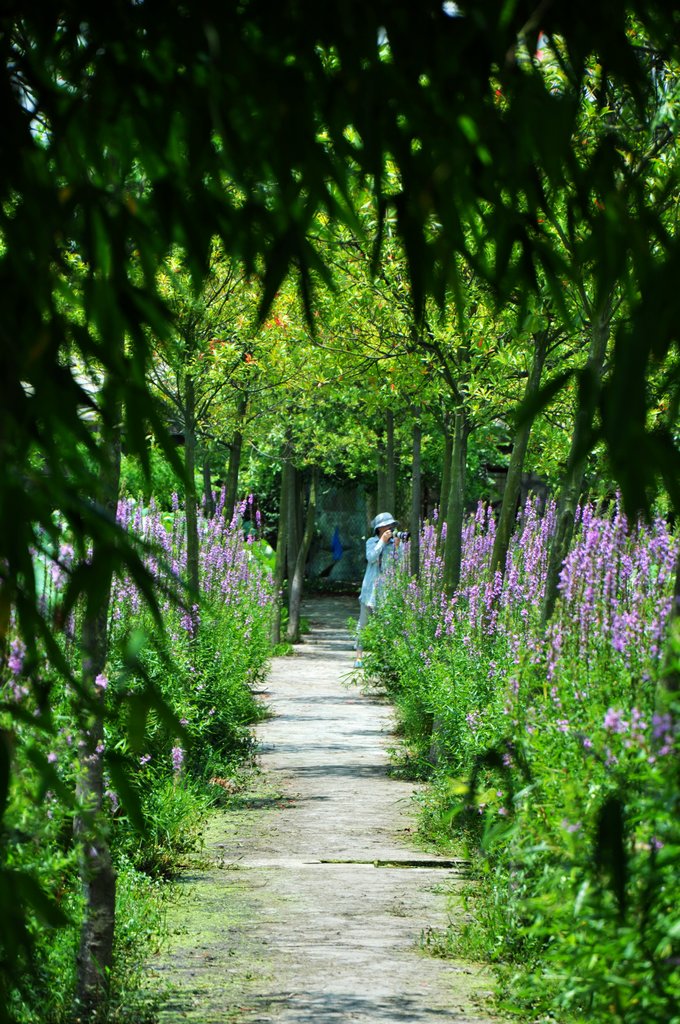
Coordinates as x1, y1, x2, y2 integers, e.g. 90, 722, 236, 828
543, 297, 611, 623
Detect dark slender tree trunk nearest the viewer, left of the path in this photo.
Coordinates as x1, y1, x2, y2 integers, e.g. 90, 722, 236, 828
74, 391, 121, 1021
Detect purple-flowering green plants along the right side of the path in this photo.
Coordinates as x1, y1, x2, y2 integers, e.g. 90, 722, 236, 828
367, 504, 680, 1024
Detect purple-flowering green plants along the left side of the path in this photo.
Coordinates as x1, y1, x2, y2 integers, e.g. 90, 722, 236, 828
2, 502, 271, 1024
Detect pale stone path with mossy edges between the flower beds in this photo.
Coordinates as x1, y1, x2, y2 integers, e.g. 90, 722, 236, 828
151, 598, 492, 1024
